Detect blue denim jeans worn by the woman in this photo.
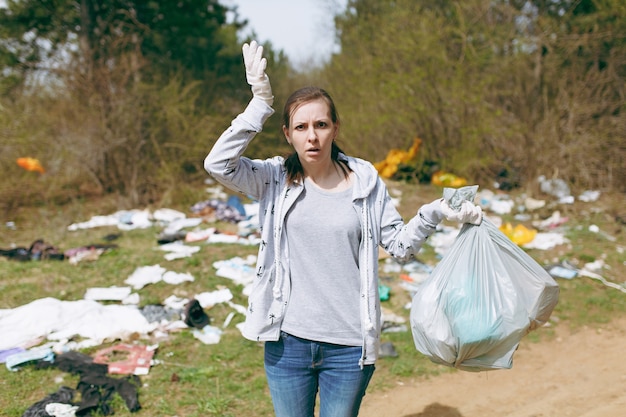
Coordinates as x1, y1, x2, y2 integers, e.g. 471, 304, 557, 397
265, 332, 374, 417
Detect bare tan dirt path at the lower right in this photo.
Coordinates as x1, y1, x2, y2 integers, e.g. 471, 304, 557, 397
359, 318, 626, 417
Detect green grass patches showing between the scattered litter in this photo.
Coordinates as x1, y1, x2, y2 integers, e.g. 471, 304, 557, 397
0, 184, 626, 417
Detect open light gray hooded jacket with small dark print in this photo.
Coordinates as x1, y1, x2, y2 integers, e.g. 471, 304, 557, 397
204, 98, 443, 366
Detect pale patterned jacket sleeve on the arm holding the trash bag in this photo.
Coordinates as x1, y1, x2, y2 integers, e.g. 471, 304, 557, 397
380, 182, 443, 261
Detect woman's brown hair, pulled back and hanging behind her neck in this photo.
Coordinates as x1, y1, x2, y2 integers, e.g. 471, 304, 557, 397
283, 87, 351, 184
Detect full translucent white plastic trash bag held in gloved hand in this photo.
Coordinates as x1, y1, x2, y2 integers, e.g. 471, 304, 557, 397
410, 186, 559, 371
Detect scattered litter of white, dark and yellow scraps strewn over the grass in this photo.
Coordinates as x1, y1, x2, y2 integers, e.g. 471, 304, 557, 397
0, 172, 626, 416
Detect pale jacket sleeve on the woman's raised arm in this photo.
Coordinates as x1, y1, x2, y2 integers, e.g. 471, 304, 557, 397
204, 98, 282, 199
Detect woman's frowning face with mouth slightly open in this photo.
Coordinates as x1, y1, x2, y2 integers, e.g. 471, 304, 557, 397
283, 99, 339, 166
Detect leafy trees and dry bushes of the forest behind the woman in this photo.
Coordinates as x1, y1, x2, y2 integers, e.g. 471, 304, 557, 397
0, 0, 626, 215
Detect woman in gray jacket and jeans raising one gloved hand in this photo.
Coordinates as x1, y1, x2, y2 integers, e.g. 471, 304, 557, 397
204, 41, 482, 417
